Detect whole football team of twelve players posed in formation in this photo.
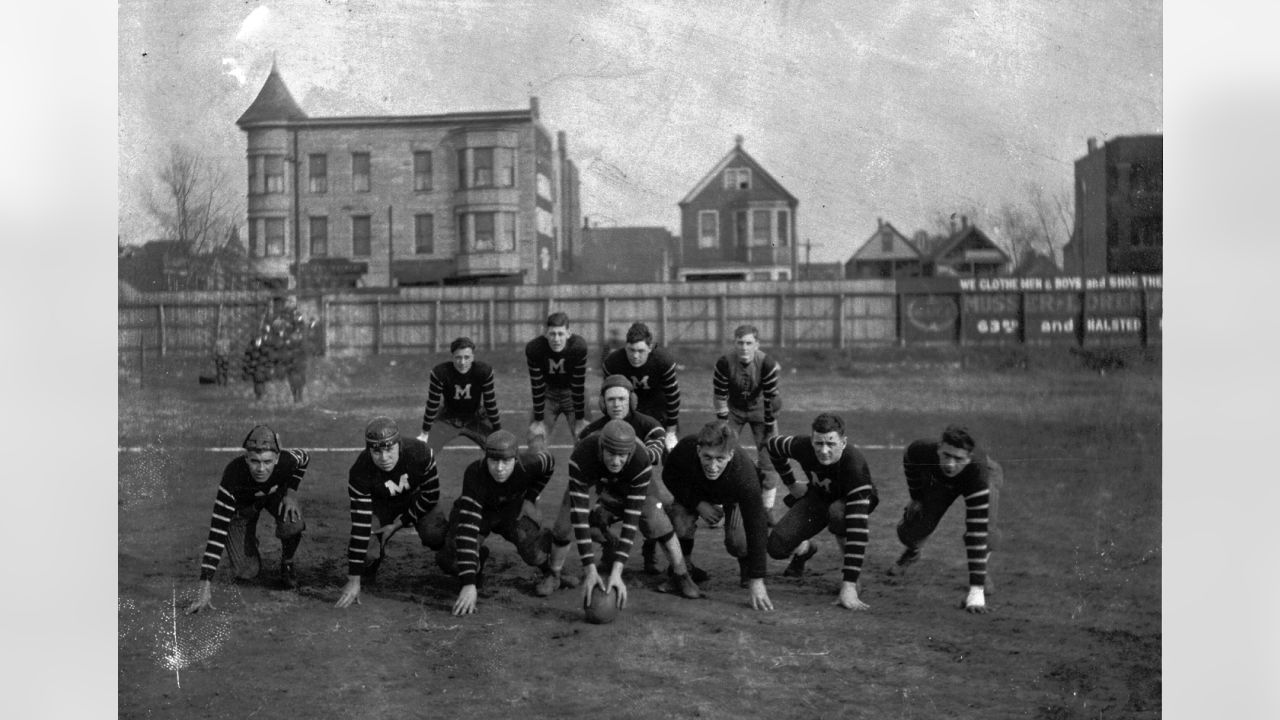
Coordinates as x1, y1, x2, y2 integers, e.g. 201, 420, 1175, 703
187, 313, 1002, 616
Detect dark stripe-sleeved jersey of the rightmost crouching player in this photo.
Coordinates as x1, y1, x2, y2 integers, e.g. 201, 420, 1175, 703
902, 439, 991, 585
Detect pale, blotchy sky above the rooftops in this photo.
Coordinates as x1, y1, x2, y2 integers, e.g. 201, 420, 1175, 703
118, 0, 1164, 261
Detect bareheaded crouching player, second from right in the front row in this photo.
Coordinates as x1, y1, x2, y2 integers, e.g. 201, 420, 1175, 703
765, 413, 879, 610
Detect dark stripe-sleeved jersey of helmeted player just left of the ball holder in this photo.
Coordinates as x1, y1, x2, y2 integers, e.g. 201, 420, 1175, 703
453, 452, 556, 585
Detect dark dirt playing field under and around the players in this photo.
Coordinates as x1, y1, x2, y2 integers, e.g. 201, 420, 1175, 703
118, 352, 1161, 720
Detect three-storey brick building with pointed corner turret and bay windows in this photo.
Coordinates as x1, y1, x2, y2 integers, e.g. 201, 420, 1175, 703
236, 65, 580, 287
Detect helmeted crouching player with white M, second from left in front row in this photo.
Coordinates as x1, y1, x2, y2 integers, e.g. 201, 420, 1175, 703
338, 416, 445, 607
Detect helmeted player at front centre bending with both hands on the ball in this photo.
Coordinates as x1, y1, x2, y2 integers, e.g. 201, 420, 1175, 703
538, 420, 701, 609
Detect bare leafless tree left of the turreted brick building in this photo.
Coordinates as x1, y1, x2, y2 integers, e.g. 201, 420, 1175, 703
147, 143, 234, 255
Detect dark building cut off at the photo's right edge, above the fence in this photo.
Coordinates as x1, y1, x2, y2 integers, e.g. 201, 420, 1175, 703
1062, 135, 1165, 275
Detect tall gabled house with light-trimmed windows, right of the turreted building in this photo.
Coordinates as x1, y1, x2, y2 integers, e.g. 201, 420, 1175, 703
676, 136, 800, 281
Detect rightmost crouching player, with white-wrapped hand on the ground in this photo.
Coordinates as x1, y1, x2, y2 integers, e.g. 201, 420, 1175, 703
888, 425, 1005, 612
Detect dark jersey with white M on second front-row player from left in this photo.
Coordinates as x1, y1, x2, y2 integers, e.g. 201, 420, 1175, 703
347, 436, 440, 575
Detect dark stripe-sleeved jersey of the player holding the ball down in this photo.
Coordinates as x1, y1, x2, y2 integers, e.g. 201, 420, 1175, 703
568, 433, 653, 571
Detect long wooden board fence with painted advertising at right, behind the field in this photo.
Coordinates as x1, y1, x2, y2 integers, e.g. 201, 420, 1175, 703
119, 270, 1161, 370
